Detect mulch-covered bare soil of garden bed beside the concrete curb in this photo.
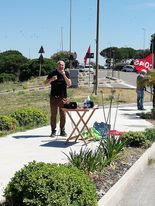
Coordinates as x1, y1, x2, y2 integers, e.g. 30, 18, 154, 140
90, 147, 146, 199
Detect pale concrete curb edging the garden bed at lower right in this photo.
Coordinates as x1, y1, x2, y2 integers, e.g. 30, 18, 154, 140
98, 143, 155, 206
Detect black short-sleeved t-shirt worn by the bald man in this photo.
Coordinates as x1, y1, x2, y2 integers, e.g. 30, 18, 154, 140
47, 70, 70, 98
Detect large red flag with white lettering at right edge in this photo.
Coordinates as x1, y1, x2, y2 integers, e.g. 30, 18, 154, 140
134, 53, 152, 73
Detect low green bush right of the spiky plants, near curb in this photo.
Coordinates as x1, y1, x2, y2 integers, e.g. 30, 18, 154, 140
122, 131, 151, 148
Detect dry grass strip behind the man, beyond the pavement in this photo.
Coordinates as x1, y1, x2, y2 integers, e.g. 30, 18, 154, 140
0, 82, 149, 115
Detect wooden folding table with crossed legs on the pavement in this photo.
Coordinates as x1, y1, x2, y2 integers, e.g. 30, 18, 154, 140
62, 105, 98, 145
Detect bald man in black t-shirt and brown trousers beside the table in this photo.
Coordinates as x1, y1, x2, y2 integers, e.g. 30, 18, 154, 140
45, 61, 72, 137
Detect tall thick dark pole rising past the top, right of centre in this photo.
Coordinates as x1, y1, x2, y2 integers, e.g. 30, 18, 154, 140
95, 0, 100, 95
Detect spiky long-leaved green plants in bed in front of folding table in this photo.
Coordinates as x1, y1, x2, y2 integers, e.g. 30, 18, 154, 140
66, 136, 126, 174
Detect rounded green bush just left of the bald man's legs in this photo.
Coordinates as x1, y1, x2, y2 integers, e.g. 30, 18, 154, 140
11, 108, 48, 127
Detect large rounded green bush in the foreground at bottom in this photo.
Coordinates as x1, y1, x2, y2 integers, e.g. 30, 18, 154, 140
4, 161, 97, 206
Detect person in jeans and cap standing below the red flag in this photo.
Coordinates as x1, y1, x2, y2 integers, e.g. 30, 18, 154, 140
136, 69, 147, 110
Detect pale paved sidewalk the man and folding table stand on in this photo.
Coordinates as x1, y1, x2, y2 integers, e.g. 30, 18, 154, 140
0, 104, 152, 203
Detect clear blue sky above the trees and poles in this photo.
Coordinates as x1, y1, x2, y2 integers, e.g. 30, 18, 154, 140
0, 0, 155, 64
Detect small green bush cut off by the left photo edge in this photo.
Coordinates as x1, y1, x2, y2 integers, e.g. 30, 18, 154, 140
0, 115, 17, 131
